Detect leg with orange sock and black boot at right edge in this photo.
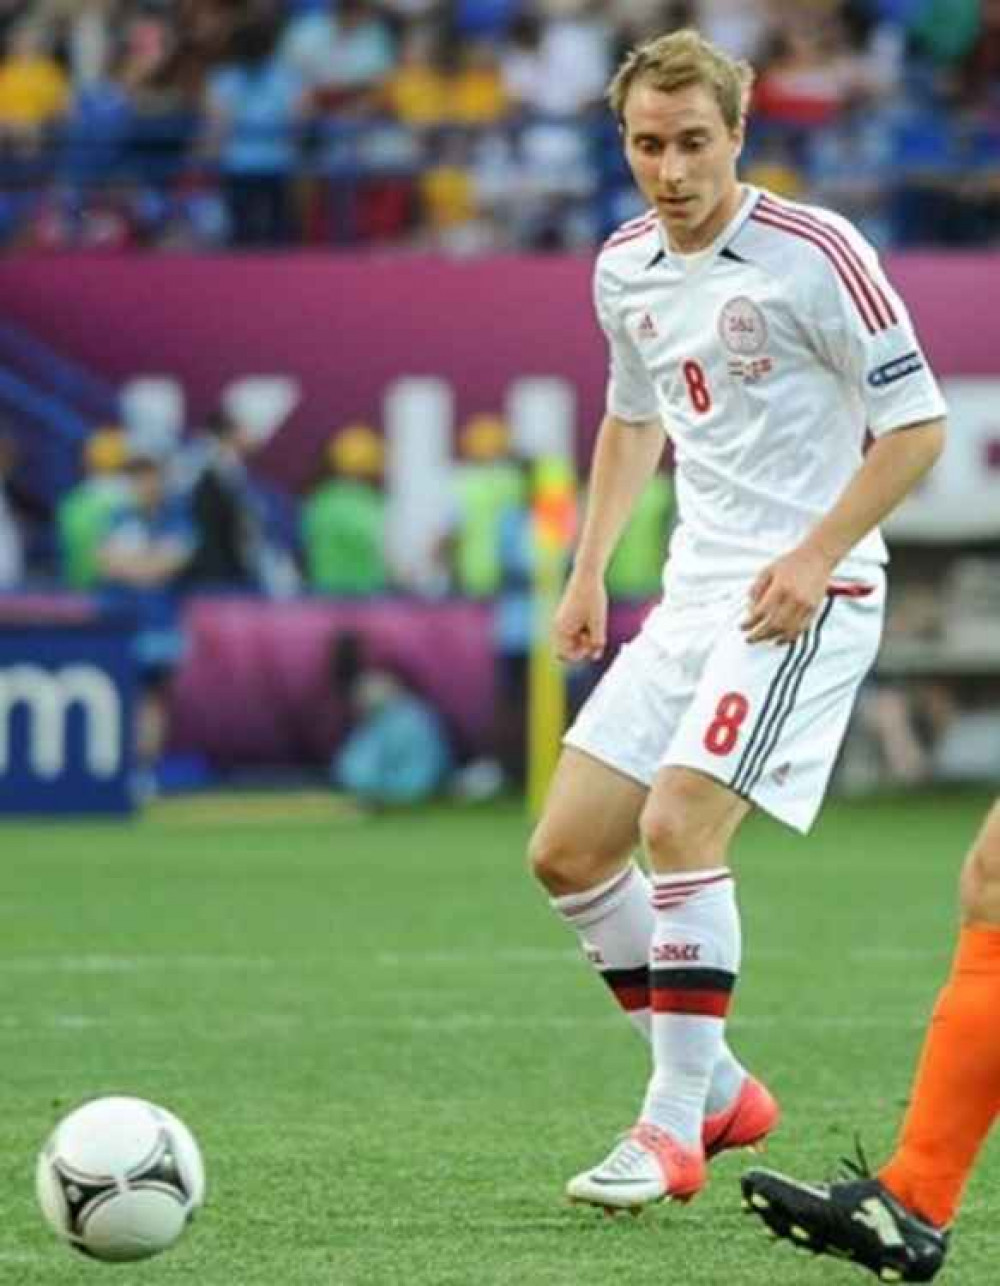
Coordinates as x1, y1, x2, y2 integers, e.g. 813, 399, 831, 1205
743, 801, 1000, 1282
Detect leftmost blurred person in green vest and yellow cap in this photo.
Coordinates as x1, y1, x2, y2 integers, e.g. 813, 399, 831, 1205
55, 426, 129, 589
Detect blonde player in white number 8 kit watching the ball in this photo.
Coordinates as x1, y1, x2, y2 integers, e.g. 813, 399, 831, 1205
531, 31, 945, 1211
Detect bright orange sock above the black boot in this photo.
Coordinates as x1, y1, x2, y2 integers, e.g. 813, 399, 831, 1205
879, 926, 1000, 1227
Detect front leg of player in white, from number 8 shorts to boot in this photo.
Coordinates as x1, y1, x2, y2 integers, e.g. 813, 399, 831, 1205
571, 583, 882, 1206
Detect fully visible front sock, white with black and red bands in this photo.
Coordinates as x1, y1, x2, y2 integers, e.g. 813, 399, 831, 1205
641, 867, 740, 1147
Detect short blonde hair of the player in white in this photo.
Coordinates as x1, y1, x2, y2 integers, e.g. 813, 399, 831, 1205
607, 27, 753, 130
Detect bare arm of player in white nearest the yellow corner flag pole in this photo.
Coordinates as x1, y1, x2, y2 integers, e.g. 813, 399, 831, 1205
553, 415, 663, 661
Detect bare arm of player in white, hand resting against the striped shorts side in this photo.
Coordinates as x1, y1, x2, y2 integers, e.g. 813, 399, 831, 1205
743, 418, 946, 643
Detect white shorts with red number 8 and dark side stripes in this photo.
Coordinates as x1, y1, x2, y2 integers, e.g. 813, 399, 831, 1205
564, 570, 886, 831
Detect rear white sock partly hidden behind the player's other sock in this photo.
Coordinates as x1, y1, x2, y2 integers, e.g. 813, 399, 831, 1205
551, 863, 747, 1112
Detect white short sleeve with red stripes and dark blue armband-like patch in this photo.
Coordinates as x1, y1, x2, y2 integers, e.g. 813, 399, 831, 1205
801, 221, 947, 437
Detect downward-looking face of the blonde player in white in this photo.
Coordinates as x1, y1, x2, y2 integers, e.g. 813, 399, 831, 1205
623, 81, 743, 252
